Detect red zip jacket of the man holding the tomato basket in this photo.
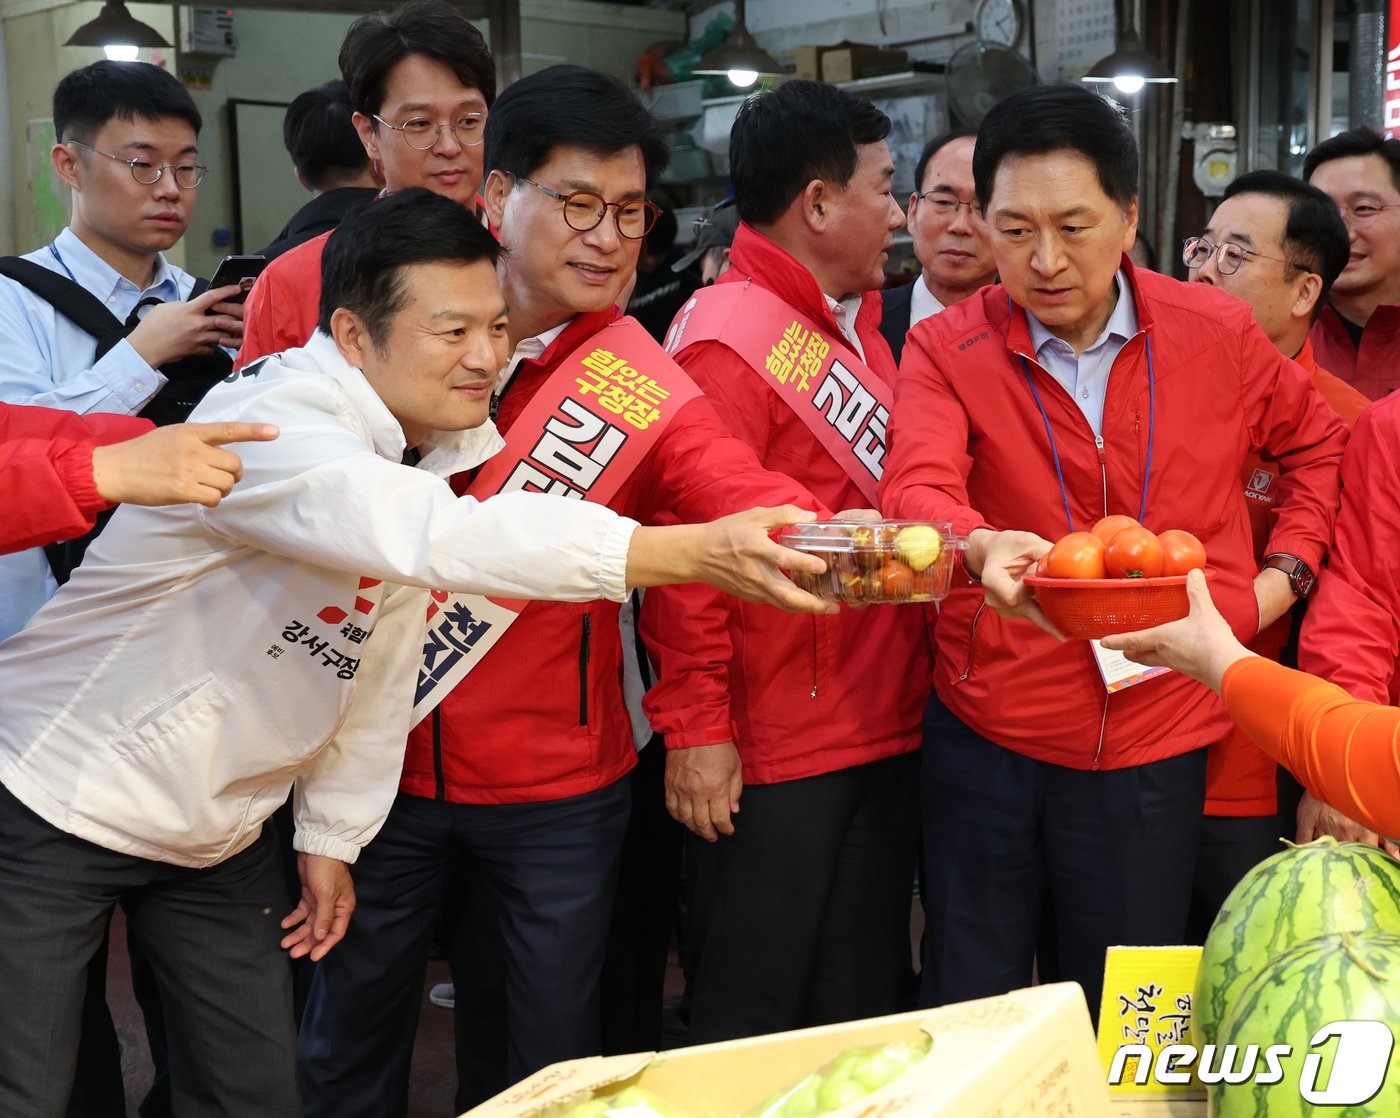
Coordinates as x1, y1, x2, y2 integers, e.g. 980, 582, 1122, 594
881, 257, 1347, 768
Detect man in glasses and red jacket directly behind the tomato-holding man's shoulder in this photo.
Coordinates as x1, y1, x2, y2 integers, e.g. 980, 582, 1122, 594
1182, 171, 1376, 943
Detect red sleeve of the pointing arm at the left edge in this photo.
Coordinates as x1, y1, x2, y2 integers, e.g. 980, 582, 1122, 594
0, 403, 154, 554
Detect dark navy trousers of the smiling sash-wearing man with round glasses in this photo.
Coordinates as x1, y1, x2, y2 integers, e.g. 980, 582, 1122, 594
298, 778, 629, 1118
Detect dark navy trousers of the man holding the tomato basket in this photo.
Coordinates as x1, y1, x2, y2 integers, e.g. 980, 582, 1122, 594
920, 705, 1205, 1020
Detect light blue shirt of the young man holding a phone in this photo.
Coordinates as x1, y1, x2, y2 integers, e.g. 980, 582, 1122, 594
0, 229, 195, 641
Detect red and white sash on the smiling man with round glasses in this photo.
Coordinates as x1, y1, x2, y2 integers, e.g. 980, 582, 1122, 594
413, 318, 700, 725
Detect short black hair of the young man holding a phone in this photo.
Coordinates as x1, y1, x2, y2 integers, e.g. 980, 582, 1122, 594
53, 60, 204, 144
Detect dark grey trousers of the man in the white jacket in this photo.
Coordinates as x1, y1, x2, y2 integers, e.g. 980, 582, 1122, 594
0, 788, 301, 1118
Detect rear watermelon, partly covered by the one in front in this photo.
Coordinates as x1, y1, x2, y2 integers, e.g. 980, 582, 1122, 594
1191, 835, 1400, 1052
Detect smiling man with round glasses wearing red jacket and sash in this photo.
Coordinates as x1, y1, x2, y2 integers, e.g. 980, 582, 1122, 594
291, 66, 823, 1118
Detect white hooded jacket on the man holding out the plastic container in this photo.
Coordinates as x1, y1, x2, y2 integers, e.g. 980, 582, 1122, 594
0, 333, 636, 868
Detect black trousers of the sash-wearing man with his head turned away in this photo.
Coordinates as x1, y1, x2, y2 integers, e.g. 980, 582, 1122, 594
687, 753, 918, 1044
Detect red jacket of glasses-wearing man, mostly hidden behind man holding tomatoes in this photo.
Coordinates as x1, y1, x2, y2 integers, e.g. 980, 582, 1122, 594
1205, 341, 1371, 816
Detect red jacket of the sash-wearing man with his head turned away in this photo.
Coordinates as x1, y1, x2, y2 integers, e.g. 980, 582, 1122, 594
643, 225, 930, 784
